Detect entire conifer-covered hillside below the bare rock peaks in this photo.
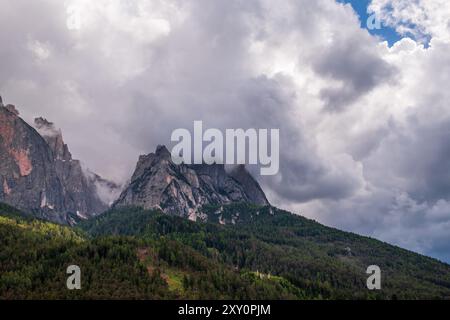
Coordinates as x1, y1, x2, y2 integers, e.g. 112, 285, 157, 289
0, 204, 450, 299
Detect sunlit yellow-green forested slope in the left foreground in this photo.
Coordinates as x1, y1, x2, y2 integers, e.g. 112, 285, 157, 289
0, 205, 306, 299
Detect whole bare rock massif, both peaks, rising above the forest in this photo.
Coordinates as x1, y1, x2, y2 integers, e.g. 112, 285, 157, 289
0, 97, 269, 224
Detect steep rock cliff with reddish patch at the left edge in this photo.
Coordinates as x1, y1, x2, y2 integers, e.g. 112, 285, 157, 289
0, 96, 118, 223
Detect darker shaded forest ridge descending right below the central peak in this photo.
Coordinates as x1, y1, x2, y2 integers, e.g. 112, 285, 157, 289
80, 203, 450, 299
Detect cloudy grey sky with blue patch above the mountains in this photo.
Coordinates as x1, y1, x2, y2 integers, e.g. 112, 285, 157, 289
0, 0, 450, 261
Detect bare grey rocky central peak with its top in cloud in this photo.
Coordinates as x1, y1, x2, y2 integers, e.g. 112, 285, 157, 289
114, 146, 269, 220
